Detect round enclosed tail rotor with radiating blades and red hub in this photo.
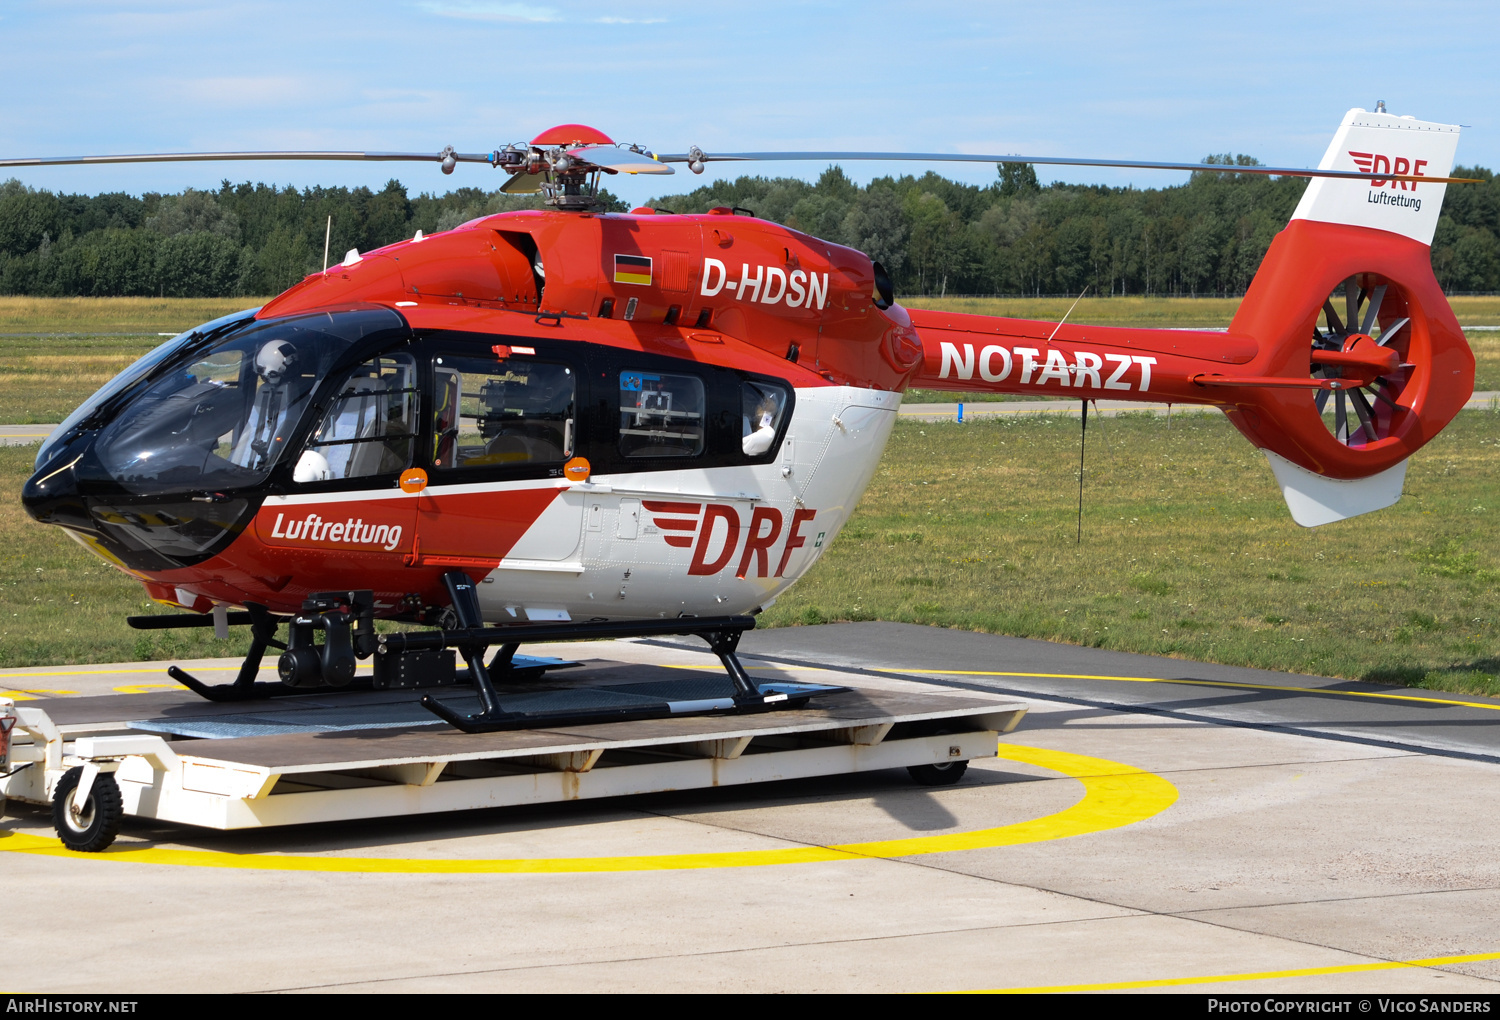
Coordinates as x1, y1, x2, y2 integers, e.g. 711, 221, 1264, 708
1311, 273, 1416, 447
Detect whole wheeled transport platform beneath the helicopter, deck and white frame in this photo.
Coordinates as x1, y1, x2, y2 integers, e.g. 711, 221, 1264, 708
0, 660, 1026, 849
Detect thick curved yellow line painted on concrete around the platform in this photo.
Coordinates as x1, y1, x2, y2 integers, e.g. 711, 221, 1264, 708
0, 744, 1178, 875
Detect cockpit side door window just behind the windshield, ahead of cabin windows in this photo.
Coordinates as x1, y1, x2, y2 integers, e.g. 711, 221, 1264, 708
293, 354, 417, 482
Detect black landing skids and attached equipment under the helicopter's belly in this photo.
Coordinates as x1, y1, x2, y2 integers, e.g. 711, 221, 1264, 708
128, 570, 792, 734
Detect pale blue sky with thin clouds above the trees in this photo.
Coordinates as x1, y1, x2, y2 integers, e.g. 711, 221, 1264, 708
0, 0, 1500, 203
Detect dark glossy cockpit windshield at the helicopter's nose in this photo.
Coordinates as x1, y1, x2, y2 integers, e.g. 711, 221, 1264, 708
21, 308, 410, 570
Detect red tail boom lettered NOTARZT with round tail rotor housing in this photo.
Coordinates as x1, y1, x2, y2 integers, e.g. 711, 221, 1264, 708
911, 219, 1475, 480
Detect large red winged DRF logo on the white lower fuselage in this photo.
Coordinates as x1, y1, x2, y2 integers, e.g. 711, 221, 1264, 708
642, 500, 818, 578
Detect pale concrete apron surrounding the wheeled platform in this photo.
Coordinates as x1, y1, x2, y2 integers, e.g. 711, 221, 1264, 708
0, 642, 1500, 995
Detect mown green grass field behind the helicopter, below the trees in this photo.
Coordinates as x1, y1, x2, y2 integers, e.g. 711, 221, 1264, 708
0, 297, 1500, 693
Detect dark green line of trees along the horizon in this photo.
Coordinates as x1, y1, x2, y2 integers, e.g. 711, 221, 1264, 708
0, 155, 1500, 297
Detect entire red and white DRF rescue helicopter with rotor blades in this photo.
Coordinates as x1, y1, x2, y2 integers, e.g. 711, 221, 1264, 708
14, 113, 1475, 731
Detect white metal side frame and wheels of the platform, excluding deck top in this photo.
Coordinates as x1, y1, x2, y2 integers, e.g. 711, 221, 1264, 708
0, 689, 1026, 851
